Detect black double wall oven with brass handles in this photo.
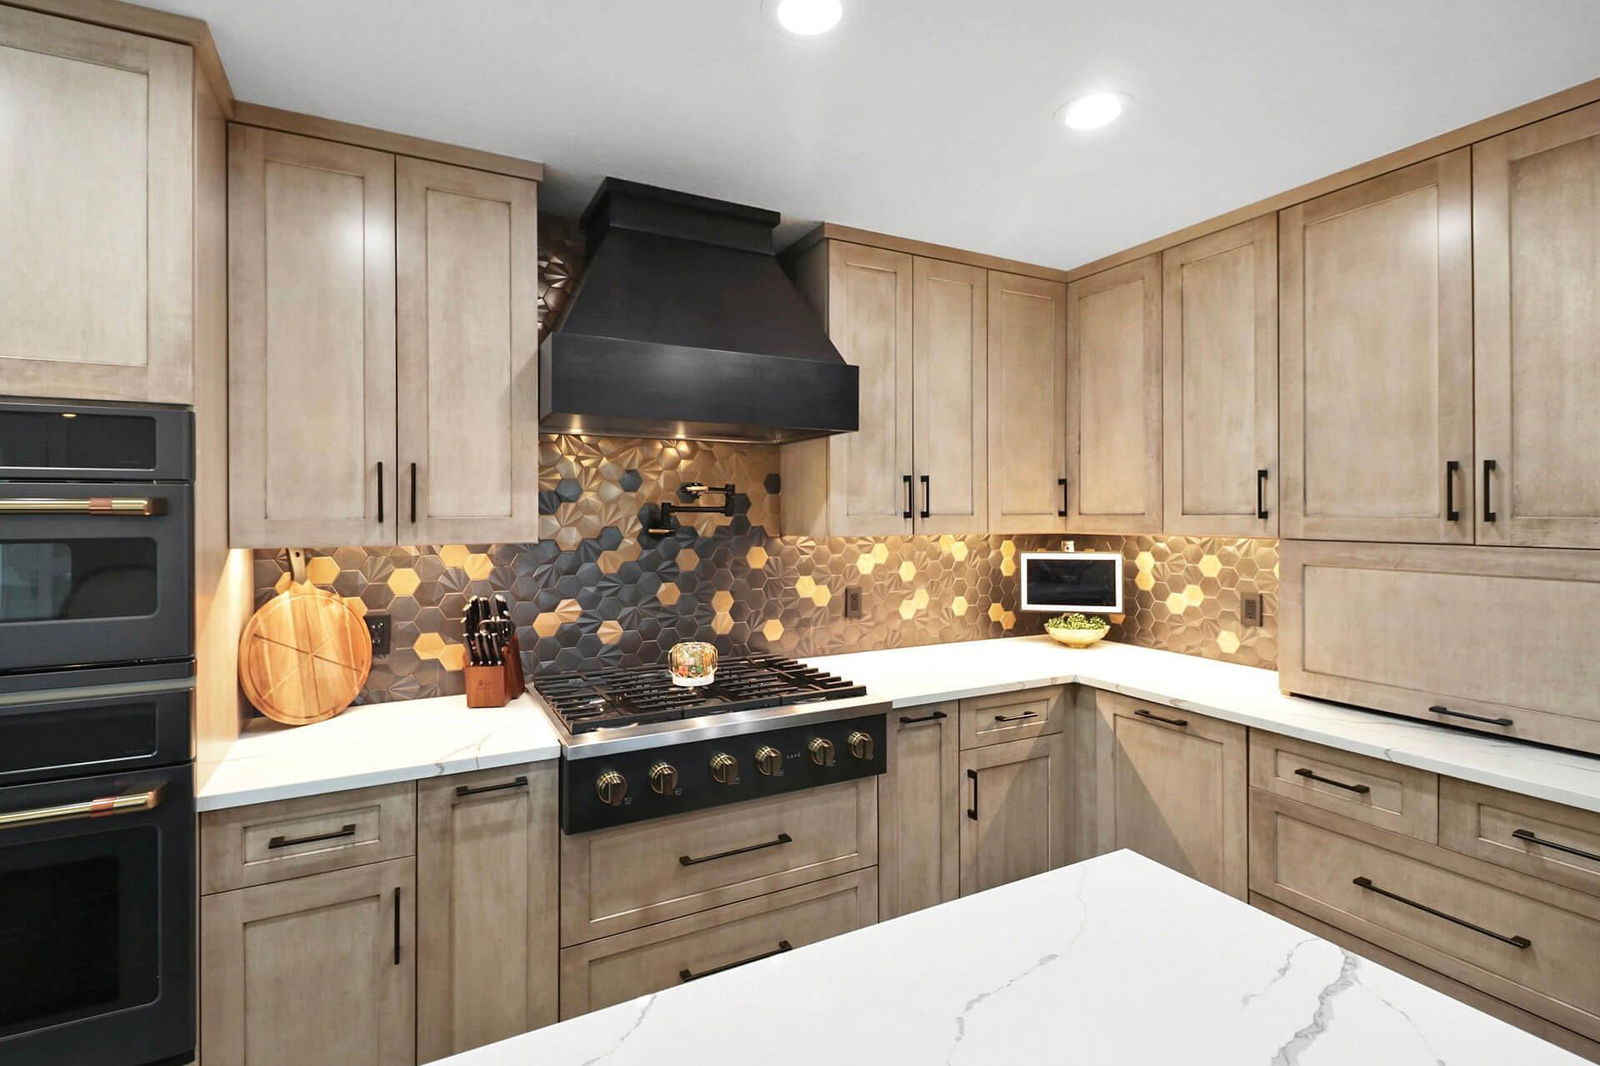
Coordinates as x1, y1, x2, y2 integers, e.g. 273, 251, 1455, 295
0, 402, 195, 1066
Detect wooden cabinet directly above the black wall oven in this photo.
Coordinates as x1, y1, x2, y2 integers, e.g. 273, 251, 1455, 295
0, 6, 195, 403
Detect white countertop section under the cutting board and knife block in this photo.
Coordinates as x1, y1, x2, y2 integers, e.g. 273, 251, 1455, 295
195, 685, 562, 810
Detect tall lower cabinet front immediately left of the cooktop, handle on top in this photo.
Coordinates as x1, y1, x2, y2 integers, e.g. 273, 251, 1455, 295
416, 762, 560, 1063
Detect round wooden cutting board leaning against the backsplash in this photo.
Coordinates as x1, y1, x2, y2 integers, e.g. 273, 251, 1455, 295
238, 584, 373, 725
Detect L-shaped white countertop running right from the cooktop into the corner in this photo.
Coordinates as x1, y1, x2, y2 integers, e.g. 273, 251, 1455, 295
806, 635, 1600, 812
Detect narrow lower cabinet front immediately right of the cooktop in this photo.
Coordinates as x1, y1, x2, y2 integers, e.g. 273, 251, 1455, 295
878, 703, 962, 920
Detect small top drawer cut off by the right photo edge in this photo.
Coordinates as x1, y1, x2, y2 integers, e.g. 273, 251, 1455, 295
1438, 778, 1600, 895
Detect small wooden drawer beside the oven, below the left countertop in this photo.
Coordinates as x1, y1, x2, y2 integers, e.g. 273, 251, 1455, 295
200, 781, 416, 895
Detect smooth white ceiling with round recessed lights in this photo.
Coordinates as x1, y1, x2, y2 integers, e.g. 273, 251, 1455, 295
155, 0, 1600, 267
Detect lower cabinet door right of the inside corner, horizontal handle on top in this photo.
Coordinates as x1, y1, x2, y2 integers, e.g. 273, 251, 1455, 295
1094, 691, 1250, 900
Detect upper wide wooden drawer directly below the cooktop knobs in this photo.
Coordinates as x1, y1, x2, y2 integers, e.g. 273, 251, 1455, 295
562, 778, 878, 944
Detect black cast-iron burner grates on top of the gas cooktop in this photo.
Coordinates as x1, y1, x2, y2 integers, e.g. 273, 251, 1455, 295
530, 655, 867, 735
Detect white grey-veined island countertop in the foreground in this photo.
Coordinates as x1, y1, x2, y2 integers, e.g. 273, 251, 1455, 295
442, 852, 1582, 1066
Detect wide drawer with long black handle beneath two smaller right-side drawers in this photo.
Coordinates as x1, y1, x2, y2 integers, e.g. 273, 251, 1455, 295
1250, 792, 1600, 1039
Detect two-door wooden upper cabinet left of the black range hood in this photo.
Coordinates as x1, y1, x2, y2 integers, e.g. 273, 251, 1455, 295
229, 125, 538, 547
